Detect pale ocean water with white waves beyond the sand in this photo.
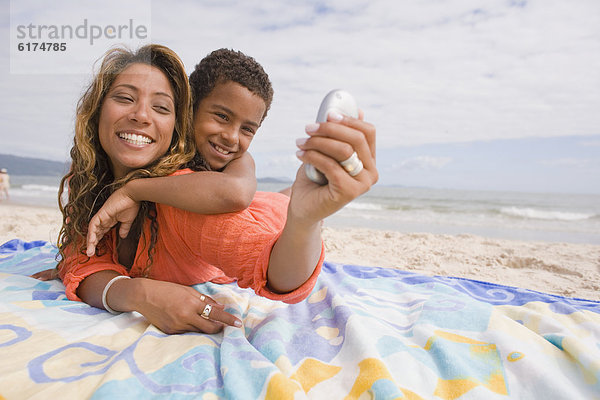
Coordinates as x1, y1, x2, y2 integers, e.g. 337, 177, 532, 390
5, 176, 600, 244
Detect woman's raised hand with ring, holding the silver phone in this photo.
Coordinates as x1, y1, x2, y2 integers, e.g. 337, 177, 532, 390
288, 112, 379, 223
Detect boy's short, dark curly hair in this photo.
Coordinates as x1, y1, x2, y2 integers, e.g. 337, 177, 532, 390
190, 49, 273, 122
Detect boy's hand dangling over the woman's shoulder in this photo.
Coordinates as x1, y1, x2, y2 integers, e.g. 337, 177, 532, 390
86, 186, 140, 257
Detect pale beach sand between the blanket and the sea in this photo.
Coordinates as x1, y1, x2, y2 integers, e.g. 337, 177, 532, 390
0, 202, 600, 301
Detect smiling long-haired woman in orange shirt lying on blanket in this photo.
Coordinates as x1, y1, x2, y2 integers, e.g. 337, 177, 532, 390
32, 45, 377, 333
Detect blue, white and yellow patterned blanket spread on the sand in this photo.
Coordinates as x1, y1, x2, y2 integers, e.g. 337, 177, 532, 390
0, 239, 600, 400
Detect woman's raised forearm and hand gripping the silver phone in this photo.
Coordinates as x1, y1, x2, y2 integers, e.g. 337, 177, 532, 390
267, 114, 378, 293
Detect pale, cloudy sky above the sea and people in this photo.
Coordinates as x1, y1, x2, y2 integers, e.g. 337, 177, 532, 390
0, 0, 600, 194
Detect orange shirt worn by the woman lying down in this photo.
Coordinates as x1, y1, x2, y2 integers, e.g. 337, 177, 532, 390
59, 192, 324, 303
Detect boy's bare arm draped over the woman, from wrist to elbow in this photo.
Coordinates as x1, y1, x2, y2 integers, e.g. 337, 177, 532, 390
124, 153, 256, 214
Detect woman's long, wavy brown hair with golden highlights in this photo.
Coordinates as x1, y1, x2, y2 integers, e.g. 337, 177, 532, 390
58, 44, 202, 274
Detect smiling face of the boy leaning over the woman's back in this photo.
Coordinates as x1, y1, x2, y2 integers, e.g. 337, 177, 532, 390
194, 81, 266, 170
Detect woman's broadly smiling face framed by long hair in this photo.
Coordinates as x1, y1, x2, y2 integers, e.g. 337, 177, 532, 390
98, 63, 175, 179
